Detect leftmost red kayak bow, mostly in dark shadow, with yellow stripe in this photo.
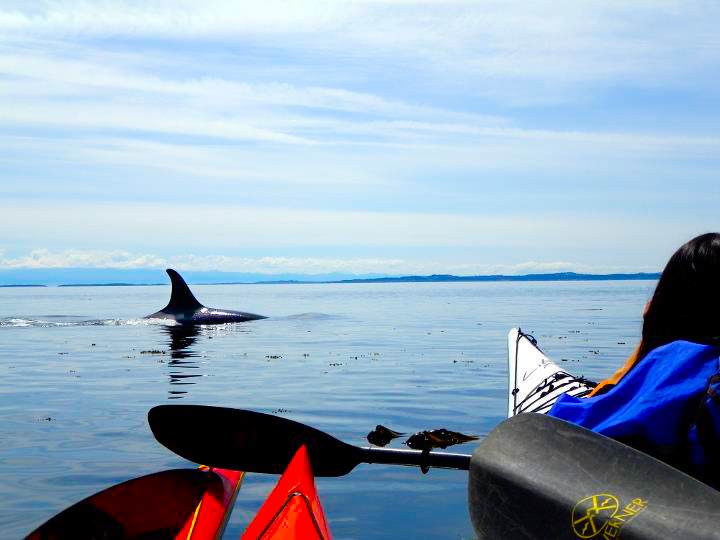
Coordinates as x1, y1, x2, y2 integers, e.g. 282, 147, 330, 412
26, 467, 245, 540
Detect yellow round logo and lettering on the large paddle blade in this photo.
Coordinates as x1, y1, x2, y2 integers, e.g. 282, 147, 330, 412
572, 493, 647, 540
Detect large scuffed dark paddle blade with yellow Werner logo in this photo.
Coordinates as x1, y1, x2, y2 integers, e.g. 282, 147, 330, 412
468, 413, 720, 540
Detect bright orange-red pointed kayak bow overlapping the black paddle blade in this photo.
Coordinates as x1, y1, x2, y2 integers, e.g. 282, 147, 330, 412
241, 446, 331, 540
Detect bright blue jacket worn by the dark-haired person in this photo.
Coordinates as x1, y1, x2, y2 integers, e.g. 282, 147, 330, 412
548, 341, 720, 488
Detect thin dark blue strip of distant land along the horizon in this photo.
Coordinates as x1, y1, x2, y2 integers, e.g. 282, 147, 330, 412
0, 272, 660, 288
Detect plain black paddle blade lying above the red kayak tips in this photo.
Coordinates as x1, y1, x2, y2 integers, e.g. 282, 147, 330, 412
148, 405, 361, 476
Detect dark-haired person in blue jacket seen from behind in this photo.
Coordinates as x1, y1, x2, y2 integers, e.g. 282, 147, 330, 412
548, 233, 720, 489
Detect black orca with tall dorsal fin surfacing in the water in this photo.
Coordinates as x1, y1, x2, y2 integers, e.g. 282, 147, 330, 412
145, 268, 267, 324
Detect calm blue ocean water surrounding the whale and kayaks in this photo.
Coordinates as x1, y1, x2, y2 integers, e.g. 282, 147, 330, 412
0, 281, 655, 539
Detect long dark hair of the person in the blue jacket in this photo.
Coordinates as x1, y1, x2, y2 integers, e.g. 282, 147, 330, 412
637, 233, 720, 360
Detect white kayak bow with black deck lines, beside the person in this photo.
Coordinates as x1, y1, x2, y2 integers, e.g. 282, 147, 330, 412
508, 328, 595, 417
